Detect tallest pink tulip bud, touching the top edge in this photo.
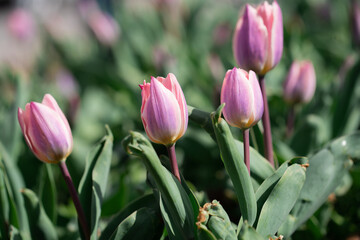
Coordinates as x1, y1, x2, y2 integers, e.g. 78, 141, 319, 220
233, 1, 283, 75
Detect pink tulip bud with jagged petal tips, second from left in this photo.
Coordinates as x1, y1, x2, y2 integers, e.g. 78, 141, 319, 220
140, 73, 188, 146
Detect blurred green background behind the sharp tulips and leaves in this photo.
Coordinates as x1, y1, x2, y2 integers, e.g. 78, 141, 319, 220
0, 0, 360, 239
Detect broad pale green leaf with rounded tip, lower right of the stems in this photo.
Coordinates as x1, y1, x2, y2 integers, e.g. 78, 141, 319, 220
256, 164, 305, 237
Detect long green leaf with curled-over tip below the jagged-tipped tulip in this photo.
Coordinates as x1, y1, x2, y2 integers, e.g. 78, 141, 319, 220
123, 132, 195, 239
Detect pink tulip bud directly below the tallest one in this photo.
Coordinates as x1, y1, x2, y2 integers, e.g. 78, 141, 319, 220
221, 68, 264, 130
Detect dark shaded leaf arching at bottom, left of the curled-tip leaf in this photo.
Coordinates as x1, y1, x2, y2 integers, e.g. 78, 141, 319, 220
99, 194, 157, 240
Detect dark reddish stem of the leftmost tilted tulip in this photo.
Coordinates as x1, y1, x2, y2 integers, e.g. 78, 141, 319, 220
59, 161, 90, 240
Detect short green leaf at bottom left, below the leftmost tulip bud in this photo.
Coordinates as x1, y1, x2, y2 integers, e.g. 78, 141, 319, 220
21, 189, 58, 240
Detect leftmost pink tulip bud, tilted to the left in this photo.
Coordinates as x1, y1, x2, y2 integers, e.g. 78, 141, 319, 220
18, 94, 73, 163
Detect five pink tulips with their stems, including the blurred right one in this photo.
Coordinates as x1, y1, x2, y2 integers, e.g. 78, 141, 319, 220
18, 1, 316, 239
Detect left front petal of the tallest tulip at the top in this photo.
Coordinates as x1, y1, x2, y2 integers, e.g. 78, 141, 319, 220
233, 4, 268, 73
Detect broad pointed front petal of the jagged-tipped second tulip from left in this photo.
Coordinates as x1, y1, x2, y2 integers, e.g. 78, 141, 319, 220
142, 78, 181, 145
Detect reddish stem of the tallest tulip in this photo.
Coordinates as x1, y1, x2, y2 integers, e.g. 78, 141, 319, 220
259, 76, 274, 166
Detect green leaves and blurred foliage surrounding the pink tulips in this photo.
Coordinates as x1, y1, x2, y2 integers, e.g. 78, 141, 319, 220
0, 0, 360, 240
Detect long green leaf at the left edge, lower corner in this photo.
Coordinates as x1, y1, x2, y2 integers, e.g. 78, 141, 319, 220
0, 142, 30, 240
